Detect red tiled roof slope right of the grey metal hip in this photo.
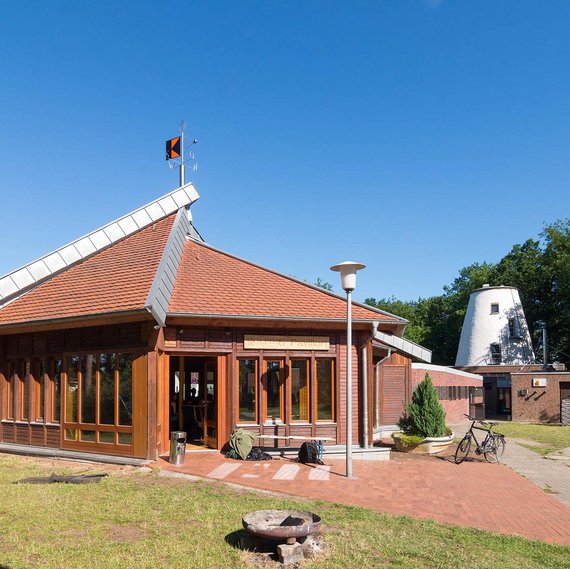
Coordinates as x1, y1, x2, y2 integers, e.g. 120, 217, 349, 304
168, 237, 402, 323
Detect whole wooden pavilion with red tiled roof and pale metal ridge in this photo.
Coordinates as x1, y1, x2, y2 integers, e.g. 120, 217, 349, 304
0, 184, 431, 460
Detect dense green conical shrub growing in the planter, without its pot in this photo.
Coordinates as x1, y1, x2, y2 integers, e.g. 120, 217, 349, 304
398, 373, 447, 438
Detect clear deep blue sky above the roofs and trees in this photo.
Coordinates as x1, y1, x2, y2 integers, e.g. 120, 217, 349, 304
0, 0, 570, 300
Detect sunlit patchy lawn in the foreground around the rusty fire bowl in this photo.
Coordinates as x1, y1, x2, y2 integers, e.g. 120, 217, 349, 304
0, 455, 570, 569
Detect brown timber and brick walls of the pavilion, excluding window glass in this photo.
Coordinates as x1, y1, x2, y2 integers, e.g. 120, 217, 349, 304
0, 319, 411, 459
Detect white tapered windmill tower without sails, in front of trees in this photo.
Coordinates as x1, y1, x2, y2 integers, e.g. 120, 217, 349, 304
455, 284, 535, 367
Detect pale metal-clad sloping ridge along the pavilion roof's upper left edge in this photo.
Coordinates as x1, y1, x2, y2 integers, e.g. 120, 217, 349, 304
0, 183, 200, 306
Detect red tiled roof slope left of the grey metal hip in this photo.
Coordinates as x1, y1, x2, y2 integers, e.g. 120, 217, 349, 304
0, 213, 176, 325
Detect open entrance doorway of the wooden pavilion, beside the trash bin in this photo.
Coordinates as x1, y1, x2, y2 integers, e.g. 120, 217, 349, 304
169, 356, 219, 448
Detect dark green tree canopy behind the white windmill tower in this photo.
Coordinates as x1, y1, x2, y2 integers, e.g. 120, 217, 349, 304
364, 219, 570, 365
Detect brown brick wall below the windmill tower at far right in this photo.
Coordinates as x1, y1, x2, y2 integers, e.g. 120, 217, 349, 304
511, 372, 570, 423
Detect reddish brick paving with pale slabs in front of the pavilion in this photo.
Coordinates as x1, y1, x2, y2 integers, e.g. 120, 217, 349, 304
158, 452, 570, 546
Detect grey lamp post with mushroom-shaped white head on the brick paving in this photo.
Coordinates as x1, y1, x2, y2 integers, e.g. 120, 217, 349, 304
331, 261, 366, 478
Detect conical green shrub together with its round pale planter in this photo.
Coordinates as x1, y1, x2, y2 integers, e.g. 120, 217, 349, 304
392, 373, 454, 454
